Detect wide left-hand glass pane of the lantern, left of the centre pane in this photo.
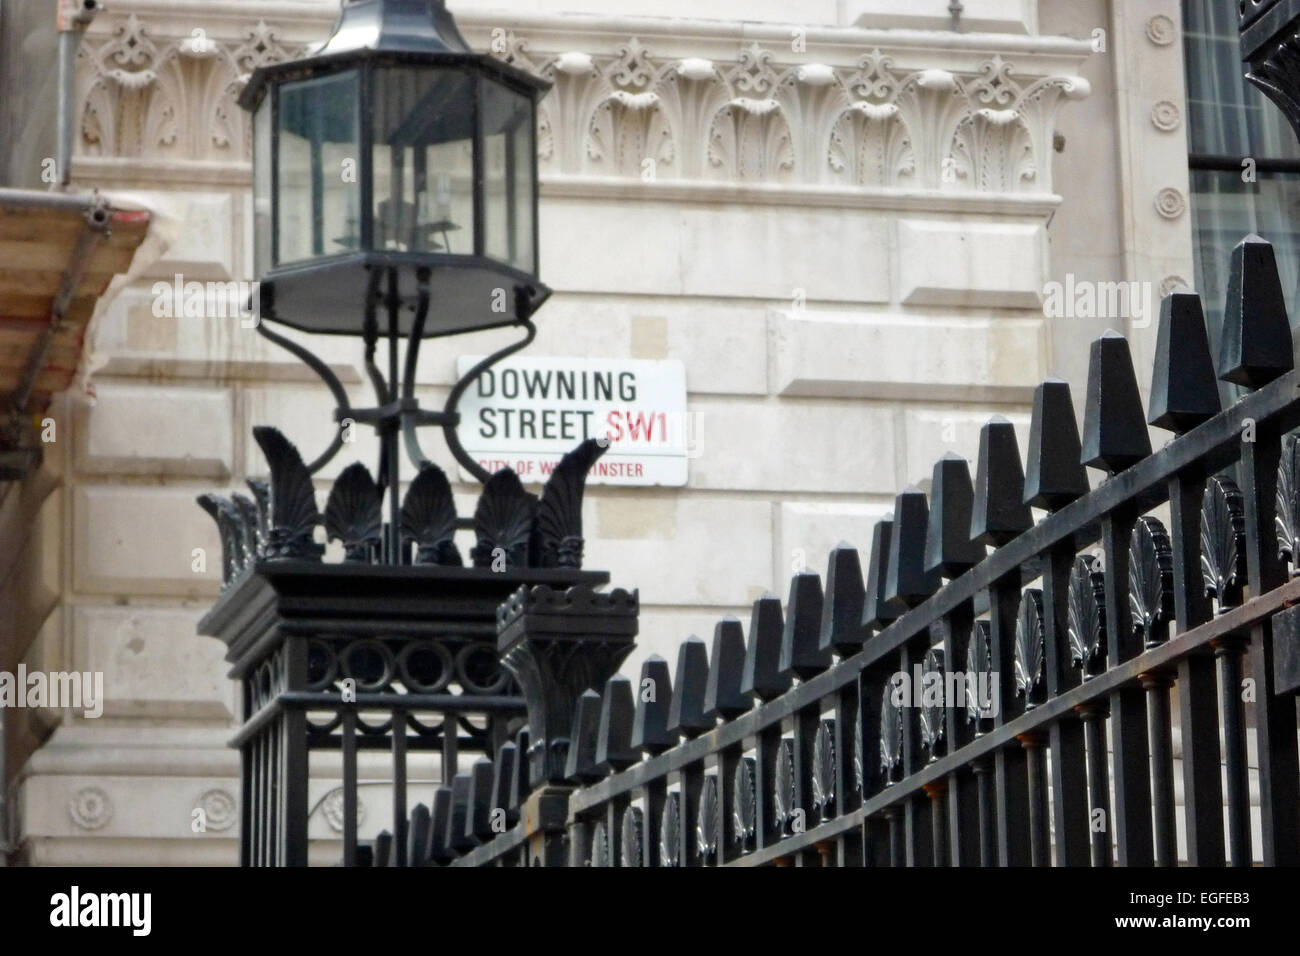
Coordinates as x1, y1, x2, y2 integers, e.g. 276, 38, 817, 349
276, 70, 360, 263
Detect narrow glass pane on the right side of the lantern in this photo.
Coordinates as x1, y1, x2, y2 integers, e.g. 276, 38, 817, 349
482, 79, 537, 272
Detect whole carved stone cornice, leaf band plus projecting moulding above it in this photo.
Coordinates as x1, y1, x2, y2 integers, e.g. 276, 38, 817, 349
78, 0, 1091, 197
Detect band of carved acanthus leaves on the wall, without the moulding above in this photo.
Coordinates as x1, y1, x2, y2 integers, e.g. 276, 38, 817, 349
79, 12, 1088, 193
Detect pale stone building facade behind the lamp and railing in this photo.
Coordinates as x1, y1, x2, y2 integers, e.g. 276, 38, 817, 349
0, 0, 1193, 864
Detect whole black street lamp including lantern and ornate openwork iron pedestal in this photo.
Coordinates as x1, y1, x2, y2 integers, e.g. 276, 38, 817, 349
199, 0, 621, 865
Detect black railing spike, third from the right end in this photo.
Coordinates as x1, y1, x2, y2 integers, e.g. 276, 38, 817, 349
1079, 329, 1151, 475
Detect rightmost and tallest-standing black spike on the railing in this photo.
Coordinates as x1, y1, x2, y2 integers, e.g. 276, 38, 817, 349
1218, 234, 1295, 389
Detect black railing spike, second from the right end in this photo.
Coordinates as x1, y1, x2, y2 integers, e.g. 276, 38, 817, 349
1147, 290, 1221, 434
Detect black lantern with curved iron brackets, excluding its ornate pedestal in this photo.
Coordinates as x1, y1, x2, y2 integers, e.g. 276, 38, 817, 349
239, 0, 550, 563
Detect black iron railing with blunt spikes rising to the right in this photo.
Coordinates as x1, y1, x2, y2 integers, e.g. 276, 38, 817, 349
412, 237, 1300, 866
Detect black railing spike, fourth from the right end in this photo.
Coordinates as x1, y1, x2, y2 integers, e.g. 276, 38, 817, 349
1023, 378, 1088, 511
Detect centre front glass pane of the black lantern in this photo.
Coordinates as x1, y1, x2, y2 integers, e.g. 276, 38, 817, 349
372, 66, 476, 255
